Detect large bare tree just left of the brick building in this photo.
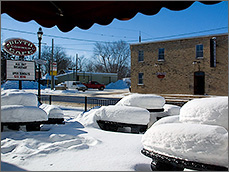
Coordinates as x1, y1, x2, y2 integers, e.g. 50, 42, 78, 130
92, 40, 130, 79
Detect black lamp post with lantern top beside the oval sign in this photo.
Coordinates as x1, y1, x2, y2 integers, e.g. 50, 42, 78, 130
37, 27, 43, 103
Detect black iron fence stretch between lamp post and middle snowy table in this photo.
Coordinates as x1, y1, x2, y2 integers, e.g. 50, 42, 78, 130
41, 95, 120, 111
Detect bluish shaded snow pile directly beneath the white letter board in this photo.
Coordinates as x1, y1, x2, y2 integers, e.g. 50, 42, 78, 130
1, 81, 46, 90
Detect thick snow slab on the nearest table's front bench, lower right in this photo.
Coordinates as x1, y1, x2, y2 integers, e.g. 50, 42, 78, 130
142, 123, 228, 166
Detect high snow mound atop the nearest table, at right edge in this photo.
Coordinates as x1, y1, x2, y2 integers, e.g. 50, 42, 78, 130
180, 96, 228, 130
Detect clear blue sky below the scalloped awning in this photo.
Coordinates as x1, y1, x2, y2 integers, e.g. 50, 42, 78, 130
1, 1, 228, 60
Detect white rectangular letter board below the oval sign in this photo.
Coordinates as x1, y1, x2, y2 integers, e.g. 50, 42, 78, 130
6, 60, 35, 81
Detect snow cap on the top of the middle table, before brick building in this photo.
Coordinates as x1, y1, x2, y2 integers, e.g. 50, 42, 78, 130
116, 94, 165, 109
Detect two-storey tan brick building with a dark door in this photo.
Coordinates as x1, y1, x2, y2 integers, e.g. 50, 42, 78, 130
130, 34, 228, 95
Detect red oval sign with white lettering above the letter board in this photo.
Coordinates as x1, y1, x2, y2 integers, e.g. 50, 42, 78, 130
3, 38, 37, 56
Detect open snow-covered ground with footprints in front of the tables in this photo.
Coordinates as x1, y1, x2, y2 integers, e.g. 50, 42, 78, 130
1, 107, 151, 171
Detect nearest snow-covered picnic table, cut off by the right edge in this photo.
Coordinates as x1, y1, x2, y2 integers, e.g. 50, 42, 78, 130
141, 97, 228, 171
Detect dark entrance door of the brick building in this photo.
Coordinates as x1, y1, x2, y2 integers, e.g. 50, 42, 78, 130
194, 71, 205, 95
